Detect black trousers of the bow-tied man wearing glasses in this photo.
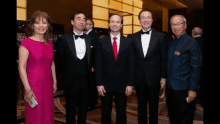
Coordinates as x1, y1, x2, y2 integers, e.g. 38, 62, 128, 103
135, 81, 160, 124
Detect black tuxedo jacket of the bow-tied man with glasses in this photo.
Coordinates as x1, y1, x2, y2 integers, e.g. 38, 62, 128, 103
130, 30, 166, 87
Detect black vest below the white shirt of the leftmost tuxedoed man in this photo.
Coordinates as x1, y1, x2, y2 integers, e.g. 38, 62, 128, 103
76, 52, 88, 75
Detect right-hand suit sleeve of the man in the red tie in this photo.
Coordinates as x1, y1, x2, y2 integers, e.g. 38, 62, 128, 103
128, 39, 135, 86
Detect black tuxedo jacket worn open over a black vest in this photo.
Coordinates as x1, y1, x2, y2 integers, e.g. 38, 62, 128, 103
57, 33, 91, 92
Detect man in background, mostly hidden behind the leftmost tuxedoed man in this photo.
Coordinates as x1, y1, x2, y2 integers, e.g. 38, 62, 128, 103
85, 19, 99, 109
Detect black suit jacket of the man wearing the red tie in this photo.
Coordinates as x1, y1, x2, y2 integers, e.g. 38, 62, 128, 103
96, 35, 134, 93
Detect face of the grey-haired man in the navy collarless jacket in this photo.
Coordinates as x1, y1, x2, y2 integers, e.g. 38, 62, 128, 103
170, 15, 186, 38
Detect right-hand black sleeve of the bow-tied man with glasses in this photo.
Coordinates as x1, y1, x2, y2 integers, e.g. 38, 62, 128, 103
161, 34, 167, 79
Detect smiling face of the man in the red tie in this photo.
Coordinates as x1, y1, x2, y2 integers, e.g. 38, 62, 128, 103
109, 15, 122, 33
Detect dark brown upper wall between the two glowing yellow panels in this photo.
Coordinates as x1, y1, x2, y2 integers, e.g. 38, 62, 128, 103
27, 0, 92, 33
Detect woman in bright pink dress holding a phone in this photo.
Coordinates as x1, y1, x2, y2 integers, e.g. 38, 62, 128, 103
18, 10, 57, 124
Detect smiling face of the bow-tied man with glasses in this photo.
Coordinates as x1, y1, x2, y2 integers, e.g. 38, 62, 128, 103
139, 11, 153, 30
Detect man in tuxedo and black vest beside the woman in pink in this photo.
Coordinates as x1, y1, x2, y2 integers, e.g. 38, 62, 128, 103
57, 11, 91, 124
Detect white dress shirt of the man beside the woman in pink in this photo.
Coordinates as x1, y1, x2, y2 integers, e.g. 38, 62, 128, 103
73, 31, 86, 60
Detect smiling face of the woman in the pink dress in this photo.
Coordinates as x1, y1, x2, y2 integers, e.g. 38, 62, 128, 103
33, 17, 49, 35
